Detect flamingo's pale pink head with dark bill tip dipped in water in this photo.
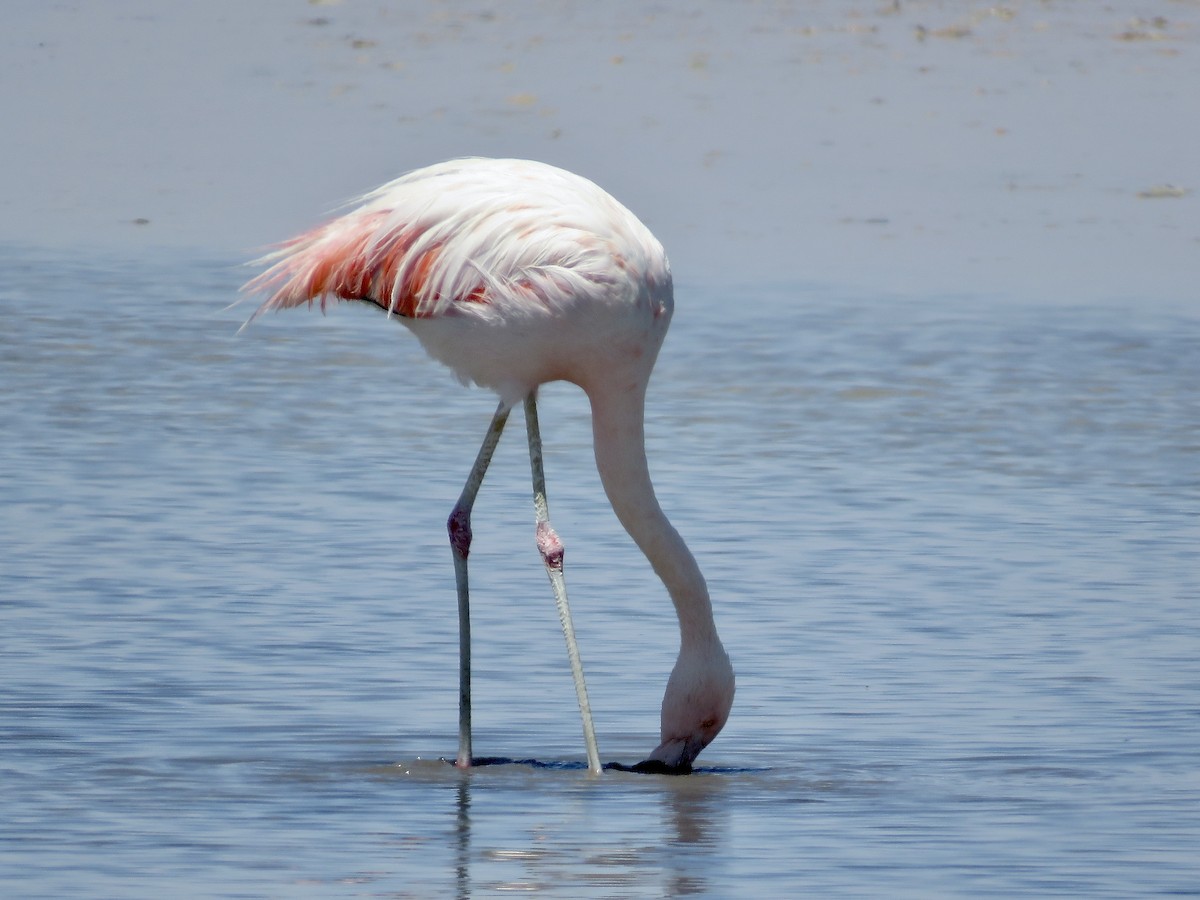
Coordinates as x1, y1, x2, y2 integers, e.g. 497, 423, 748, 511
635, 641, 734, 774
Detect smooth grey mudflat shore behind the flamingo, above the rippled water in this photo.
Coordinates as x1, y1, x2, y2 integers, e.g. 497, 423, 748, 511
0, 0, 1200, 305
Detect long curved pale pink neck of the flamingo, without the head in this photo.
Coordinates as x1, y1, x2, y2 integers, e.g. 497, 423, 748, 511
589, 384, 718, 644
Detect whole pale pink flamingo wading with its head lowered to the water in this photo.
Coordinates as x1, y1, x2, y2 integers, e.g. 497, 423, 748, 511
242, 158, 734, 773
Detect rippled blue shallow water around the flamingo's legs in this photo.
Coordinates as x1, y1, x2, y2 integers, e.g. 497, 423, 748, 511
0, 248, 1200, 898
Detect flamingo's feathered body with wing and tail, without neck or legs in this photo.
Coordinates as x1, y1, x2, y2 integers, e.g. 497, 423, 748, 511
246, 158, 673, 404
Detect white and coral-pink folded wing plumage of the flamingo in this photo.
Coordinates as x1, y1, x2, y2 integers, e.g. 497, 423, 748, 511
235, 160, 661, 324
